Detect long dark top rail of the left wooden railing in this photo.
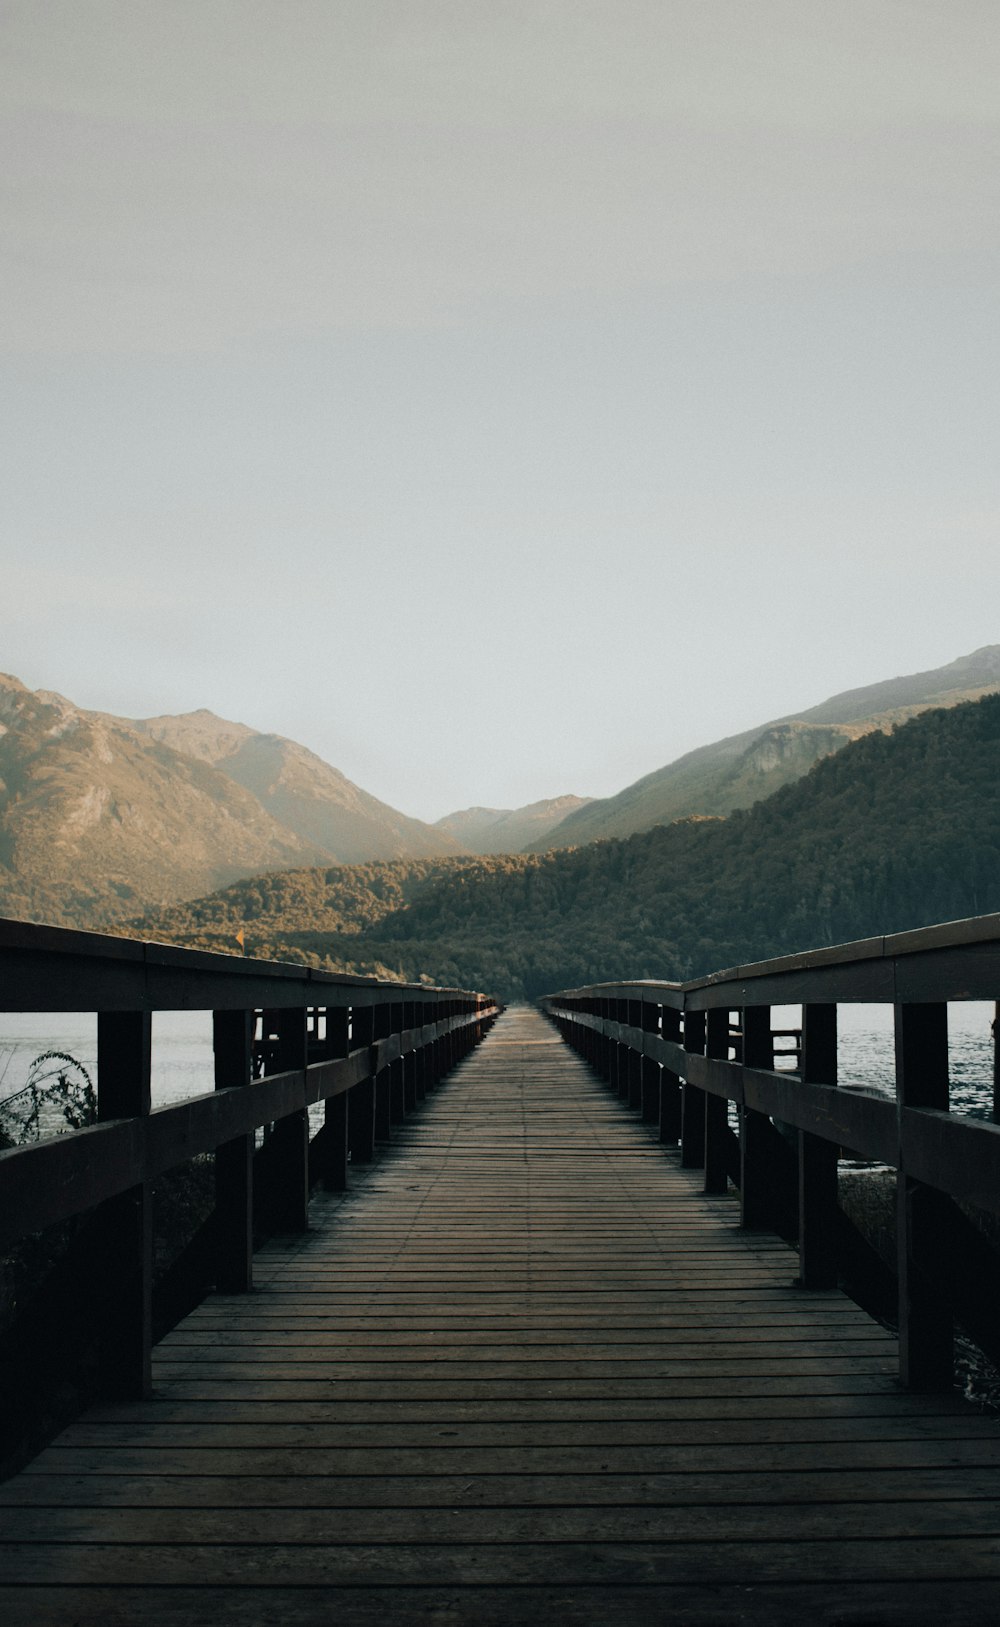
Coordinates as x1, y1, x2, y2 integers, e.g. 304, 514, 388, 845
0, 918, 480, 1012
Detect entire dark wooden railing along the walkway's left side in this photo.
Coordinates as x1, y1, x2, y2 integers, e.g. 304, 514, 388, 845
0, 921, 498, 1463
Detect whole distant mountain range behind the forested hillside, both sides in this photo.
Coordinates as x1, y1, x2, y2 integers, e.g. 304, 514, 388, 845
0, 644, 1000, 927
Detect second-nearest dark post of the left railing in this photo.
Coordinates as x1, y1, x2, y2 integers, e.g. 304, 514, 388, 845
211, 1010, 255, 1293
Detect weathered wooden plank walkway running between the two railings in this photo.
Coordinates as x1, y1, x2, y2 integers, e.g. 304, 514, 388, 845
0, 1010, 1000, 1627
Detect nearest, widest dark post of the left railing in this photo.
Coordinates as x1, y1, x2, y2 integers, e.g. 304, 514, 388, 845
98, 1012, 153, 1401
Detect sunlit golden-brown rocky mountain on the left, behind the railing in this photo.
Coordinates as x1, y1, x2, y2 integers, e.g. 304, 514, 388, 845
0, 675, 457, 926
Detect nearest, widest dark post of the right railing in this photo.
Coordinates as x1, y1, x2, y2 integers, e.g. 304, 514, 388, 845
894, 1002, 954, 1391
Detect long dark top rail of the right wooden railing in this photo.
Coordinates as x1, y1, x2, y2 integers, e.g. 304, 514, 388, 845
548, 914, 1000, 1009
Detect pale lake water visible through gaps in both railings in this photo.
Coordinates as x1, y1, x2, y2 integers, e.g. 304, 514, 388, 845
0, 1001, 993, 1131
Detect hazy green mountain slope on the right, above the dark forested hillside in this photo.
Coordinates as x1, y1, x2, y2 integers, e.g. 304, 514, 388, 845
530, 644, 1000, 851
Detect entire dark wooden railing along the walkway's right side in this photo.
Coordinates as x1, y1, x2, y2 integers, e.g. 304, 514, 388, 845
540, 916, 1000, 1389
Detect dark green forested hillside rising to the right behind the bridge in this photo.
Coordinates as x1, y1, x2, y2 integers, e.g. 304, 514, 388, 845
137, 696, 1000, 999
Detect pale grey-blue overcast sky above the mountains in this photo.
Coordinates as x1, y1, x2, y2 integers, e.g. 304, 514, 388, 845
0, 0, 1000, 818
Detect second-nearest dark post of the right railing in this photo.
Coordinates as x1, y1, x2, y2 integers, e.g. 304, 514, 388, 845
798, 1005, 839, 1289
